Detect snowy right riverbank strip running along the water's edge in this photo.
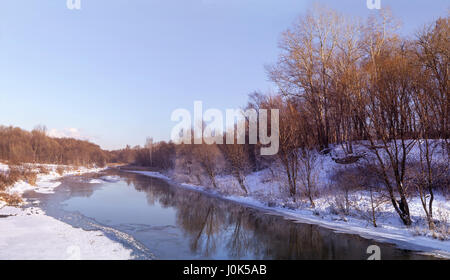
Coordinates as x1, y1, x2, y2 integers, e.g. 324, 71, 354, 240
122, 162, 450, 259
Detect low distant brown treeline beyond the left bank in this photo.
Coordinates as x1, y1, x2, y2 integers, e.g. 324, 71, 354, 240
0, 126, 109, 166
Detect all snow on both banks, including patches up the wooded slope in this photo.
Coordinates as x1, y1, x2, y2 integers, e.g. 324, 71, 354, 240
0, 145, 450, 259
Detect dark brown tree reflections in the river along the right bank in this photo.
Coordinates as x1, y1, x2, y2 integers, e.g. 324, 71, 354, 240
117, 171, 436, 259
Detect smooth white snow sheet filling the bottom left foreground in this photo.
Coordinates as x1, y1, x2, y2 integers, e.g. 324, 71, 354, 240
0, 206, 132, 260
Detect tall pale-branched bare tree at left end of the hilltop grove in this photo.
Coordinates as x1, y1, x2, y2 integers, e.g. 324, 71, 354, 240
269, 7, 343, 148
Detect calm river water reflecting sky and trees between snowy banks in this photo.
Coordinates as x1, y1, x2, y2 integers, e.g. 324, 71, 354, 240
23, 170, 440, 259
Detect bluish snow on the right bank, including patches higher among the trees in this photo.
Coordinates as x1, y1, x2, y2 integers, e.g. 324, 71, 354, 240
125, 145, 450, 258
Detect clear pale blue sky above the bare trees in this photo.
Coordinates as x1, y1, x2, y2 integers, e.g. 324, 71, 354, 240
0, 0, 450, 149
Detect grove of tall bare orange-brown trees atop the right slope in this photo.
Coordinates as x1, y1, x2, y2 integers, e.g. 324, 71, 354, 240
257, 9, 450, 152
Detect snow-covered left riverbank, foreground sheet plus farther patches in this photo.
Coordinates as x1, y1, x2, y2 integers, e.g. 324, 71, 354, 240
0, 165, 132, 260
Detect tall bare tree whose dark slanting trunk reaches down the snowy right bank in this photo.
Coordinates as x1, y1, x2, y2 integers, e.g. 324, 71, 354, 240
358, 11, 415, 228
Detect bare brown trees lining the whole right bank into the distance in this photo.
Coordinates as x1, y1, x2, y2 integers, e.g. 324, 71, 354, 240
118, 8, 450, 228
